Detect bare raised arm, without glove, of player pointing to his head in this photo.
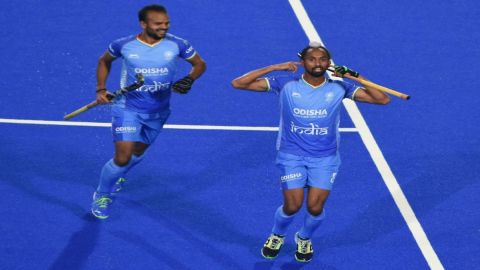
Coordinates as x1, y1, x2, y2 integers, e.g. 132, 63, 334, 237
232, 62, 300, 92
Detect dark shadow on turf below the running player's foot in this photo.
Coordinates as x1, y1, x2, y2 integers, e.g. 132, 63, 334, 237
49, 213, 102, 270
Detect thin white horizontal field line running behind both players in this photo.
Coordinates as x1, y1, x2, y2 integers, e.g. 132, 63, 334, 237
0, 118, 358, 132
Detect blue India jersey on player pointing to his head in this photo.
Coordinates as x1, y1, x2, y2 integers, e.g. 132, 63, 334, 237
265, 76, 359, 157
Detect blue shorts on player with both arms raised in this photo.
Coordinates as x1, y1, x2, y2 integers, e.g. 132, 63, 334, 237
276, 151, 341, 190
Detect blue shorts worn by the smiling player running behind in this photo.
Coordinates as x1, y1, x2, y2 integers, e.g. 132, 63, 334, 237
112, 106, 170, 145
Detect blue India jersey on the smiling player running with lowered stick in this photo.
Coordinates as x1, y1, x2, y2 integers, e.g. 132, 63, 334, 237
108, 34, 196, 113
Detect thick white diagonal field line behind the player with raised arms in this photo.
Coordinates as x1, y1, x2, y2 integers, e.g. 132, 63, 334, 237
289, 0, 444, 269
